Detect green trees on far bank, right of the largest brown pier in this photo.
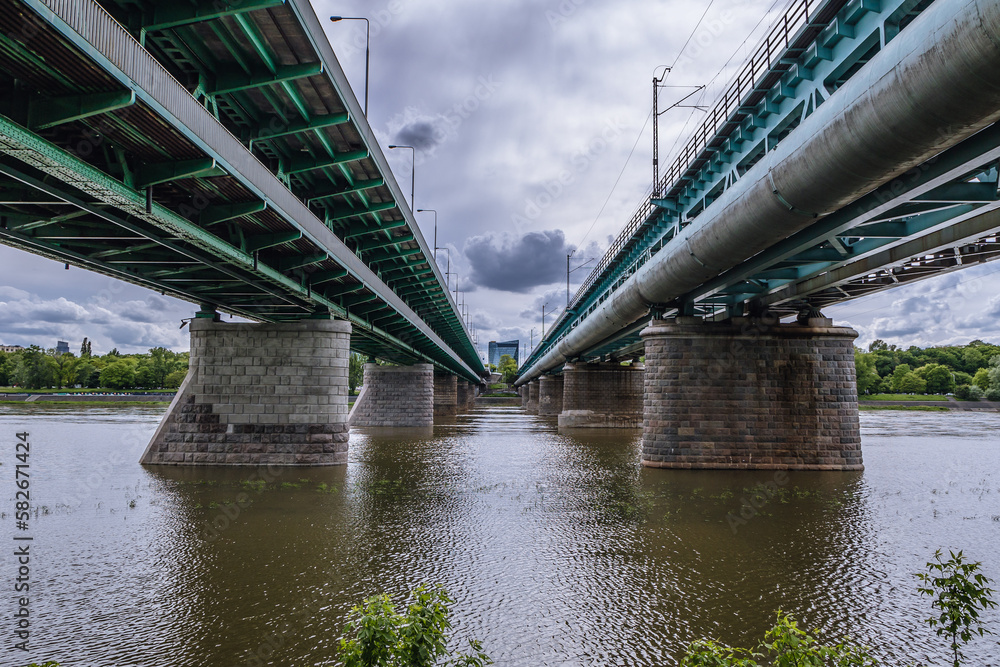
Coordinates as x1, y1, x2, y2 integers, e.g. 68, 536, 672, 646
854, 340, 1000, 401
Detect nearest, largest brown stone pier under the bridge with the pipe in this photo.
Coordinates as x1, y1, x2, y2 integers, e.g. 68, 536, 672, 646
642, 317, 864, 470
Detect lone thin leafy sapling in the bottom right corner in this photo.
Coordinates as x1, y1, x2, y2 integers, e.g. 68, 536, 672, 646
916, 549, 997, 667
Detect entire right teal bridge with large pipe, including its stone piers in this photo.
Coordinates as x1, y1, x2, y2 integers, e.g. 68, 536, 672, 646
517, 0, 1000, 470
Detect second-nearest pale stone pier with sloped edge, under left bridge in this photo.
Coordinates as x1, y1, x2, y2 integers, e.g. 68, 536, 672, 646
350, 364, 434, 427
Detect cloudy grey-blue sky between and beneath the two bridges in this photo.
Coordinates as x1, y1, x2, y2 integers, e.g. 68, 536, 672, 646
0, 0, 1000, 354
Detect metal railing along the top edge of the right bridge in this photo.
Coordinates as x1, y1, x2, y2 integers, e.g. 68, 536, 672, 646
571, 0, 832, 307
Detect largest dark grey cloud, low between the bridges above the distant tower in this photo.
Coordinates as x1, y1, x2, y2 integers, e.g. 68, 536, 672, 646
464, 229, 574, 294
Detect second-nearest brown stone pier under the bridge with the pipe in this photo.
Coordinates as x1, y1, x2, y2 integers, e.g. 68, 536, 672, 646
559, 361, 644, 428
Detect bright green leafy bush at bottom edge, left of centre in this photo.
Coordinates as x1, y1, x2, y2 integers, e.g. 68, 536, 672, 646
340, 585, 493, 667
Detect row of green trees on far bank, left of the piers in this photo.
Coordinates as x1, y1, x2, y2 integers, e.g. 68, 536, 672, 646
0, 338, 188, 390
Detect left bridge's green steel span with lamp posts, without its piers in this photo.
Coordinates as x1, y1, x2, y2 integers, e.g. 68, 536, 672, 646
0, 0, 484, 383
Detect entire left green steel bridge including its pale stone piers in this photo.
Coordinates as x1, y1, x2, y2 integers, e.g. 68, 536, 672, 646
0, 0, 485, 465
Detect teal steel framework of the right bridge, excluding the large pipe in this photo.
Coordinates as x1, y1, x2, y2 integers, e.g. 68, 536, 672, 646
522, 0, 1000, 374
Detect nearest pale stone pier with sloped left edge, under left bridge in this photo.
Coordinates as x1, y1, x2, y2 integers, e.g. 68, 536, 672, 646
140, 318, 351, 466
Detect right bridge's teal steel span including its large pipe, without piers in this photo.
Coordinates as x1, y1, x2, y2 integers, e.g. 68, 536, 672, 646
518, 0, 1000, 384
